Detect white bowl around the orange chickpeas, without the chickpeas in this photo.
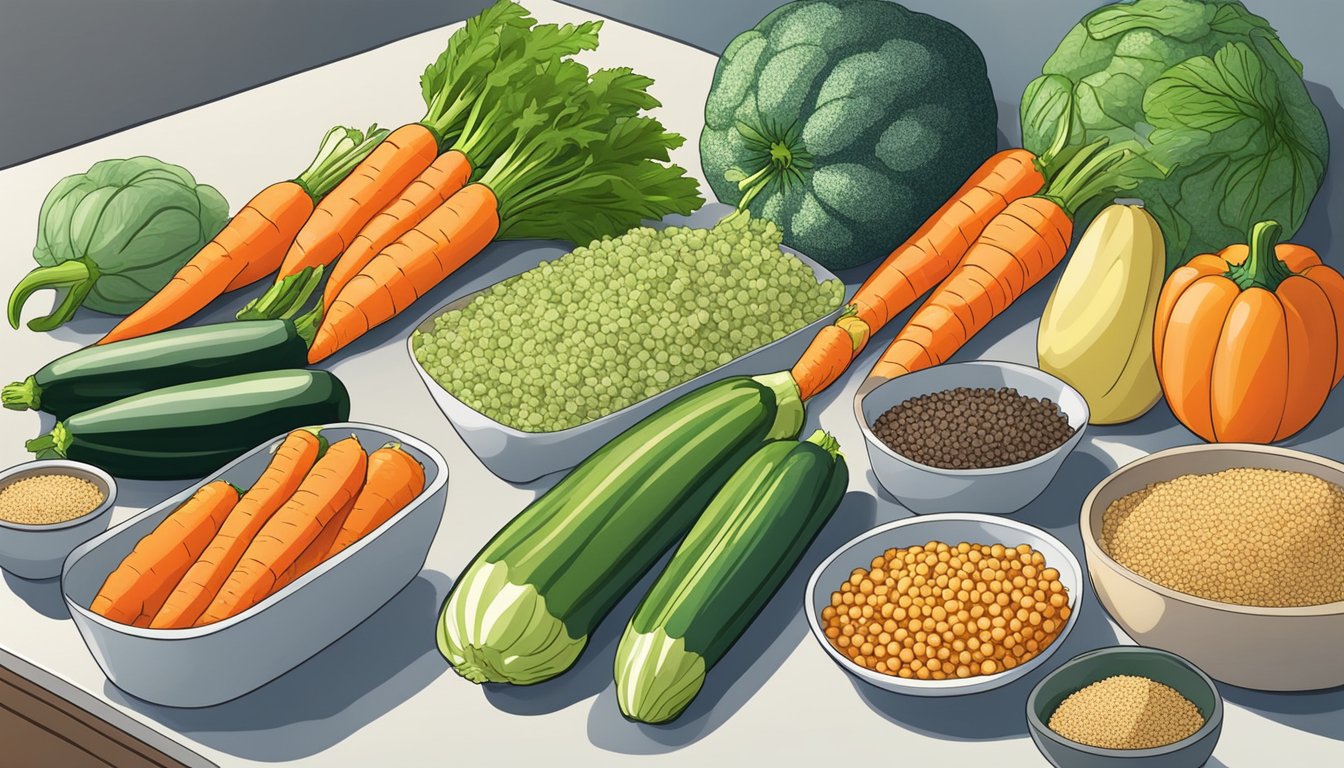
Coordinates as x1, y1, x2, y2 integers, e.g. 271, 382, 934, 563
805, 512, 1083, 697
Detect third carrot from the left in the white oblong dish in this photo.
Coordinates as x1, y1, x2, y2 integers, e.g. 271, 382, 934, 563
195, 437, 368, 627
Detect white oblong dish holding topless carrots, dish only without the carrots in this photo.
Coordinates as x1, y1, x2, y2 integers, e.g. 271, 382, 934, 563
60, 422, 448, 707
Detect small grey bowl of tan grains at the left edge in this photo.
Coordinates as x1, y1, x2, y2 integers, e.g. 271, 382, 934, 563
0, 459, 117, 578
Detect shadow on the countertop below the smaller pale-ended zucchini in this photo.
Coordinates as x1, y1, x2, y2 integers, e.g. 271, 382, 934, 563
589, 491, 876, 755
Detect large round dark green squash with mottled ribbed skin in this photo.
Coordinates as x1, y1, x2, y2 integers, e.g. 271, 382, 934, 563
700, 0, 997, 269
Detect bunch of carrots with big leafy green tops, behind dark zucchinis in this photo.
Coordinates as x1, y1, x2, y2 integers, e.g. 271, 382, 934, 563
99, 0, 702, 363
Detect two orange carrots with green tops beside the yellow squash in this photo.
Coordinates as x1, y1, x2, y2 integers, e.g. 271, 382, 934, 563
790, 116, 1157, 399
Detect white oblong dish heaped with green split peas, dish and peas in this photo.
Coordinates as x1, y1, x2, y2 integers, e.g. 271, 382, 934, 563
407, 206, 845, 483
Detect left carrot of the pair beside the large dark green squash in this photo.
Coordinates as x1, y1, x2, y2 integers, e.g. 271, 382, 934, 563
792, 149, 1044, 399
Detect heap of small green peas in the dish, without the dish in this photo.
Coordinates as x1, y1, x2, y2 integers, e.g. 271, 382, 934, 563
414, 218, 844, 432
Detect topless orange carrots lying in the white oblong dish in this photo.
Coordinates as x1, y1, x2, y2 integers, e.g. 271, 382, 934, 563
91, 429, 425, 629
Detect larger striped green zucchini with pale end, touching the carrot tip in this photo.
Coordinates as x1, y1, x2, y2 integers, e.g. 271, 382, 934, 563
438, 373, 802, 685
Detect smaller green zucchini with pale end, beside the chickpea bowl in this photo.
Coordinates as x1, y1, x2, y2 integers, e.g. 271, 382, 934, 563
616, 429, 849, 722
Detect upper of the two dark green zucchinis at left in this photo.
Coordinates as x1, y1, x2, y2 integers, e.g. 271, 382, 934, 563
0, 320, 308, 418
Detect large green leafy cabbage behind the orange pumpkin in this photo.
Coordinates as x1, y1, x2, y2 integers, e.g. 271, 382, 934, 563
1021, 0, 1329, 270
